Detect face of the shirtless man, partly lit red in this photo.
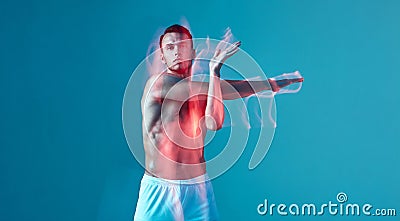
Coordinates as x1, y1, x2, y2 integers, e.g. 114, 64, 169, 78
161, 32, 195, 75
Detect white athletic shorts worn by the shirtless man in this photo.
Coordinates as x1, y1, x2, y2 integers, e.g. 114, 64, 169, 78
134, 174, 219, 221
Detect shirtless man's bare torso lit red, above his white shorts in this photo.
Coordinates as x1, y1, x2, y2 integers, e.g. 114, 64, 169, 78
141, 73, 206, 180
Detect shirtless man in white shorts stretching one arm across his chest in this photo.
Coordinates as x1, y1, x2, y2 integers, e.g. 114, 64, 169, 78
134, 25, 303, 221
